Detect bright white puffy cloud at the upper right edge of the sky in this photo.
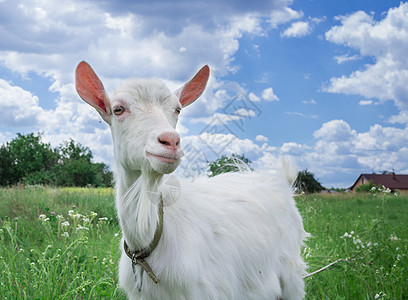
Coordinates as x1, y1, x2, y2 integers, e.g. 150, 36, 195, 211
326, 2, 408, 111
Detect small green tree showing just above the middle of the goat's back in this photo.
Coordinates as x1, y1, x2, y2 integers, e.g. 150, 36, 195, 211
208, 154, 252, 177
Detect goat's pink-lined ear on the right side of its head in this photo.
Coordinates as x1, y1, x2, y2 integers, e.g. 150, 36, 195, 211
175, 65, 210, 107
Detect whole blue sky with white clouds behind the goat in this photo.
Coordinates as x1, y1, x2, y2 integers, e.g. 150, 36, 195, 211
0, 0, 408, 187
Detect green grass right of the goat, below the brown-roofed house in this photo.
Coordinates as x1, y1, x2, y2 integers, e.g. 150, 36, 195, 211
297, 194, 408, 299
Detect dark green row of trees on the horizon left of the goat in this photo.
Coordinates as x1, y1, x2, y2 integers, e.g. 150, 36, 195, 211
0, 133, 112, 187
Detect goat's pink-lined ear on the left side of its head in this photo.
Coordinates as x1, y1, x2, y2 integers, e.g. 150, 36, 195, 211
75, 61, 112, 123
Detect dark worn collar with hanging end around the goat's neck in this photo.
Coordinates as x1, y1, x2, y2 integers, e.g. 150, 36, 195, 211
123, 194, 164, 283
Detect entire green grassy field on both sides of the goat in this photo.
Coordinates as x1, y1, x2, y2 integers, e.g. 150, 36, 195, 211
0, 187, 408, 299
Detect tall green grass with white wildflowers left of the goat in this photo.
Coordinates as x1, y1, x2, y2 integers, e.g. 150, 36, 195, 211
0, 188, 124, 299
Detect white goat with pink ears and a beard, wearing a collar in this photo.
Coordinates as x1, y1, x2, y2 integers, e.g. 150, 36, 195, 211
76, 62, 306, 300
